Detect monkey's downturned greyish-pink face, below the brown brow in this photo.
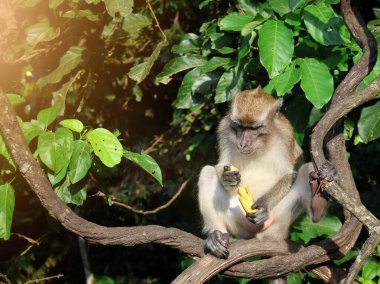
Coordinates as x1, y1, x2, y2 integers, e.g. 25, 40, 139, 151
230, 119, 269, 155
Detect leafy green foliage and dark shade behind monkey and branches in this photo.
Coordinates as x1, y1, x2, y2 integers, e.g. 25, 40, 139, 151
0, 0, 380, 283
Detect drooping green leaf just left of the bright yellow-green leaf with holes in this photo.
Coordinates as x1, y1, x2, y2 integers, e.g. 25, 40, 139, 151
68, 140, 92, 184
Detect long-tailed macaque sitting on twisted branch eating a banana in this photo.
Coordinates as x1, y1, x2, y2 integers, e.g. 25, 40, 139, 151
198, 88, 322, 258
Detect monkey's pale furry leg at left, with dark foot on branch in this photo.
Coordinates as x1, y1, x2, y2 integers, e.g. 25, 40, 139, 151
198, 166, 229, 258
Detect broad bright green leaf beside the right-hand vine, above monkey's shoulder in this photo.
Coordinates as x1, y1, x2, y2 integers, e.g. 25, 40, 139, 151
300, 58, 334, 108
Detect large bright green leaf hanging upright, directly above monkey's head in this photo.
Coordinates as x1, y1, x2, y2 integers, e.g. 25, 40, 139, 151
258, 20, 294, 78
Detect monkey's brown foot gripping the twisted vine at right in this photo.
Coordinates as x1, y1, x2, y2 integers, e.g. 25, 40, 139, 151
309, 162, 338, 222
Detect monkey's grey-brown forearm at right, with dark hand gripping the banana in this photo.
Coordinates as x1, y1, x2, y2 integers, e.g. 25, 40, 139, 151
247, 173, 297, 225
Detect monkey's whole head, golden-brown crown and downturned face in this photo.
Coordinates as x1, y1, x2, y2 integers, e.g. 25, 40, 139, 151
227, 87, 282, 155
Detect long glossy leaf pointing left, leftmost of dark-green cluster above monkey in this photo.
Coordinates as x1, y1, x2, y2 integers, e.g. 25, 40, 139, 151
156, 55, 206, 84
